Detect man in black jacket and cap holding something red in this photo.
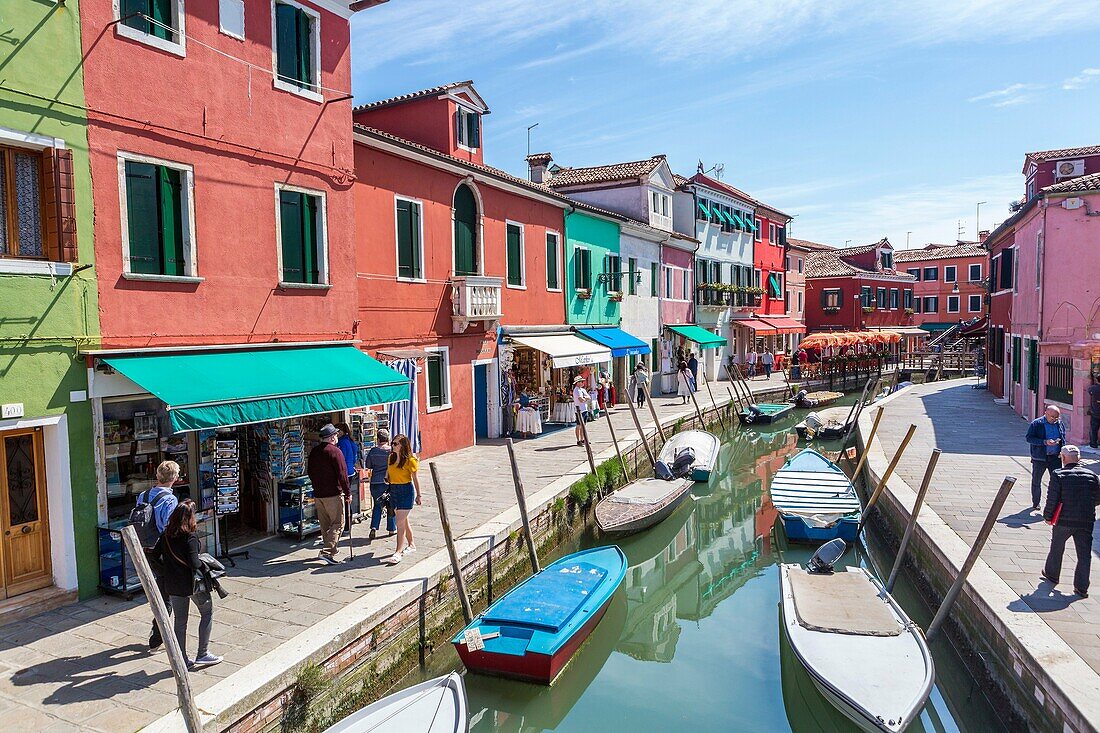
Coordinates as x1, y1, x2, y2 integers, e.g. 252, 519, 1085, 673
1040, 446, 1100, 598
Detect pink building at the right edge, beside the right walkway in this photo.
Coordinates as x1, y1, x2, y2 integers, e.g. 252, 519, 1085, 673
986, 165, 1100, 445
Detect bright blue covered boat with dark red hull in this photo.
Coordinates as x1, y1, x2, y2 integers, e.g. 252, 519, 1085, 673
451, 545, 627, 685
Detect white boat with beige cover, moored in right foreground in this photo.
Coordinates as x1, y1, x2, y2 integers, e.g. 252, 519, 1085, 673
780, 565, 935, 733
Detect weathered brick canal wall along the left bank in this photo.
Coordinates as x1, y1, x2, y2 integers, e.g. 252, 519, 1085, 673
223, 385, 788, 733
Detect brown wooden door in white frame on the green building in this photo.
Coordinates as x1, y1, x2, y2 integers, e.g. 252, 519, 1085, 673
0, 428, 53, 598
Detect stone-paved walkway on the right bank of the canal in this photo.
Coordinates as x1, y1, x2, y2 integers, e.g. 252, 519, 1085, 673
862, 380, 1100, 672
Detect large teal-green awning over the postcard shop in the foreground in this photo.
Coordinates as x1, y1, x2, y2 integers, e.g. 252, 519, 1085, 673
103, 346, 410, 433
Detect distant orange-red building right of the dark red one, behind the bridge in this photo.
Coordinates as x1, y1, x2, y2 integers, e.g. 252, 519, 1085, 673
894, 242, 989, 332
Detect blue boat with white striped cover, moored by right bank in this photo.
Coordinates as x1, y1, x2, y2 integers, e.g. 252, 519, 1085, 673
771, 448, 861, 543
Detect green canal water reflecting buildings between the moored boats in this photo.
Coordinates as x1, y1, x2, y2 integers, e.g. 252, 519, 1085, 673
398, 407, 1004, 733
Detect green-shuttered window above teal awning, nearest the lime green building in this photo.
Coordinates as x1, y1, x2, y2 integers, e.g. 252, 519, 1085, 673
119, 156, 195, 277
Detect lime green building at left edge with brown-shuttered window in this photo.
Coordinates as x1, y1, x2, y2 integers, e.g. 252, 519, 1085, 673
0, 0, 99, 603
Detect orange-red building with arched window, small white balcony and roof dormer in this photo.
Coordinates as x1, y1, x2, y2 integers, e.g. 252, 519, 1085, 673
353, 81, 569, 456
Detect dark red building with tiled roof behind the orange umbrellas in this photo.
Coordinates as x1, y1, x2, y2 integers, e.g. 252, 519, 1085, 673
805, 239, 916, 333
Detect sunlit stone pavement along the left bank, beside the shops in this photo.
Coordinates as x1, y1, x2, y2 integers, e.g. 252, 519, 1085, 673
0, 375, 783, 733
